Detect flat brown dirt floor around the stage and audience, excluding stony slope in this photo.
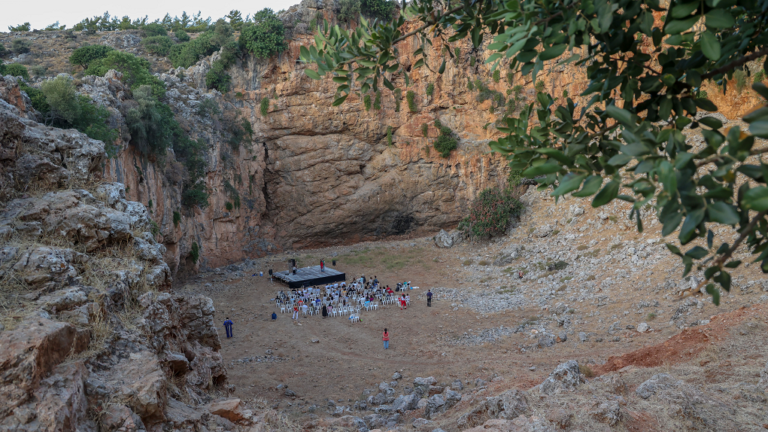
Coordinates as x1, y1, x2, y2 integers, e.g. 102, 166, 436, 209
178, 238, 768, 413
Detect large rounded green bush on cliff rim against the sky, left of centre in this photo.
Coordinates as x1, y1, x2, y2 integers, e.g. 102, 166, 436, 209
240, 8, 288, 58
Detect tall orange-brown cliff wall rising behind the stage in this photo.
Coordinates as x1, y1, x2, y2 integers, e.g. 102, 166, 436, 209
81, 0, 758, 270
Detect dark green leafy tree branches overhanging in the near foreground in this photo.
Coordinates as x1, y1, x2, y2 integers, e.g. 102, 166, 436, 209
301, 0, 768, 303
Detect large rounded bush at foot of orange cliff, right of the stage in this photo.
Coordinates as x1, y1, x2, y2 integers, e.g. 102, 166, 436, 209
459, 188, 523, 239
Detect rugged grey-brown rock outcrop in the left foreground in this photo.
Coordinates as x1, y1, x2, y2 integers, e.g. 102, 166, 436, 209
0, 77, 296, 432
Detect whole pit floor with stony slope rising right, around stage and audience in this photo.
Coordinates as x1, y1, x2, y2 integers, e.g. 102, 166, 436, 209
177, 188, 768, 430
